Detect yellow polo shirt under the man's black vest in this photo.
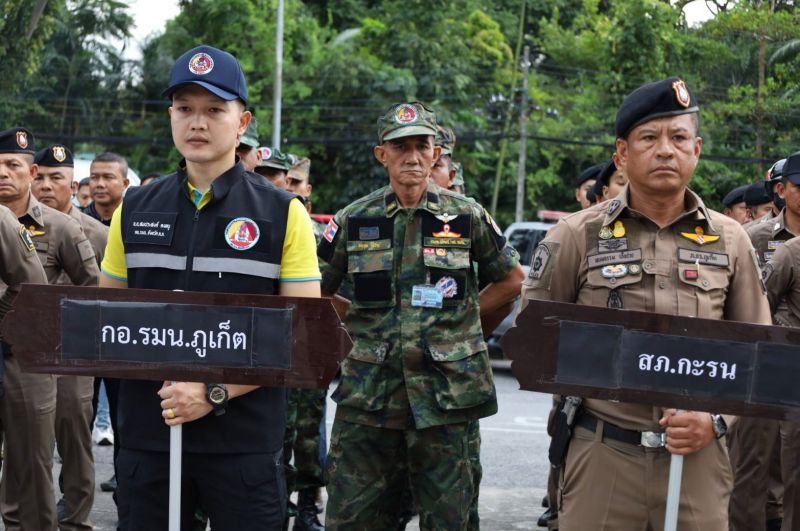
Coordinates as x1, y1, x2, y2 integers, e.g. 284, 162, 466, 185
101, 183, 322, 282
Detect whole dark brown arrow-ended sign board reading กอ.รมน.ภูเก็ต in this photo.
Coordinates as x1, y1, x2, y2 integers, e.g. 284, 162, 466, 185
0, 284, 353, 389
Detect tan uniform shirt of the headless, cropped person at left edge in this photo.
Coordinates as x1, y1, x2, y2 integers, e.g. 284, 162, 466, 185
0, 205, 47, 326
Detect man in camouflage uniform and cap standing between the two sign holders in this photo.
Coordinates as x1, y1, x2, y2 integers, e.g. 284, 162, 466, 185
318, 102, 523, 530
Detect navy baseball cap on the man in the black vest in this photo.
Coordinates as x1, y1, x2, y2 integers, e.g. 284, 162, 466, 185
162, 44, 247, 105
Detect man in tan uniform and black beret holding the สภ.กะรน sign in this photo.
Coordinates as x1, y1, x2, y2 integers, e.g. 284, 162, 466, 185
522, 78, 770, 531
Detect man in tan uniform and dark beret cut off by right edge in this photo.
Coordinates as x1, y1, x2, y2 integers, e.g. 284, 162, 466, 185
764, 152, 800, 531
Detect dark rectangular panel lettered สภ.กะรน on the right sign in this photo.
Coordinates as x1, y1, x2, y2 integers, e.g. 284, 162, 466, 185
555, 320, 800, 407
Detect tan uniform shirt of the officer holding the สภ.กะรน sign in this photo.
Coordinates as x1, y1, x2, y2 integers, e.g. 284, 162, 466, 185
521, 186, 771, 431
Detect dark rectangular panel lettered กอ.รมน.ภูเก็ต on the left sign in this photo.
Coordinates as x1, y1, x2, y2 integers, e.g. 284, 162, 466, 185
61, 299, 292, 369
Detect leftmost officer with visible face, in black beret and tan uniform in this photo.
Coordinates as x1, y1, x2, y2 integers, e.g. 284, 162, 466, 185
0, 127, 100, 529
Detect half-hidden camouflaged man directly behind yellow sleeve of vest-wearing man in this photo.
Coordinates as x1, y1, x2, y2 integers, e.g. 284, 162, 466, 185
283, 155, 328, 531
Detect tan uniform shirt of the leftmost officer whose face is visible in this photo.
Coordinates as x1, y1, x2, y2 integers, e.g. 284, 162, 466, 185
19, 195, 100, 286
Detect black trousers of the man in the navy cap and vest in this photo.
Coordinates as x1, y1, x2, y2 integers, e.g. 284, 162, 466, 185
117, 448, 286, 531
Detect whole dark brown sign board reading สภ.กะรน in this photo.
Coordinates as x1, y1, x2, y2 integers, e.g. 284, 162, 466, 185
502, 301, 800, 420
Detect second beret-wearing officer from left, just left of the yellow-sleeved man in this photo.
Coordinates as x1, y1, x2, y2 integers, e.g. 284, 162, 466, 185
31, 144, 108, 529
